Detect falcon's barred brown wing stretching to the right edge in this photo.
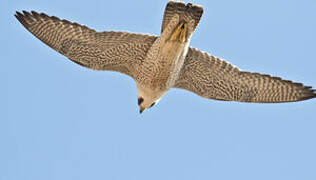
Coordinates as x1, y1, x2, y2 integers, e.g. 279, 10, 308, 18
175, 48, 316, 103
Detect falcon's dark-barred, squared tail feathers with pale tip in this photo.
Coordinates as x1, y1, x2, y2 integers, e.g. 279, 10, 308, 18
161, 1, 203, 32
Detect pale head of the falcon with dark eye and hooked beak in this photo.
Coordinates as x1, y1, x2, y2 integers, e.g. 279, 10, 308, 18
138, 87, 165, 113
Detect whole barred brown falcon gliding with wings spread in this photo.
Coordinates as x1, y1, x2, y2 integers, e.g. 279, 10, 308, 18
15, 1, 316, 113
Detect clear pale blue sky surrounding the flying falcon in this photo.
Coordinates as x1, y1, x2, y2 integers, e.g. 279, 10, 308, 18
0, 0, 316, 180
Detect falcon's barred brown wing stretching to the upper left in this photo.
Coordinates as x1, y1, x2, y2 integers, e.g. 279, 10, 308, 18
15, 11, 156, 78
